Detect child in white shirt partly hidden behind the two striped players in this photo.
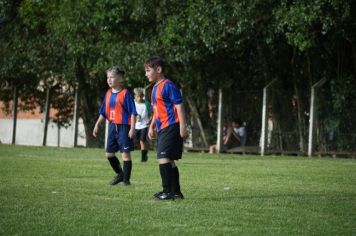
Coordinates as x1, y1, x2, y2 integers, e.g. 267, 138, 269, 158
134, 88, 152, 162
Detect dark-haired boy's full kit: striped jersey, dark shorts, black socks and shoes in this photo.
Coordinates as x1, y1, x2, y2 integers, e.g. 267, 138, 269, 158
151, 79, 184, 200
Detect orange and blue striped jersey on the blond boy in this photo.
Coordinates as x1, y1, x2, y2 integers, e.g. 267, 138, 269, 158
99, 89, 137, 125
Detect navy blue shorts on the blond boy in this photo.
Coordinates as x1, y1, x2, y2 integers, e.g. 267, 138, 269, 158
106, 123, 134, 153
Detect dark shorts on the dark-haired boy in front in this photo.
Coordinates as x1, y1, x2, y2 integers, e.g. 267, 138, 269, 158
157, 124, 183, 160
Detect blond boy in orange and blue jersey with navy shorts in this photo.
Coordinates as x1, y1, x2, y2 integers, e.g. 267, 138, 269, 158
93, 67, 137, 186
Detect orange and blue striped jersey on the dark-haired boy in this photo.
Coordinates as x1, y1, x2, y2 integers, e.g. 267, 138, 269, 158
151, 79, 183, 131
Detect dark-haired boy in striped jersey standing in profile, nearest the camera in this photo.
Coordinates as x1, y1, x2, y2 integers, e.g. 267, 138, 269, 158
144, 57, 186, 200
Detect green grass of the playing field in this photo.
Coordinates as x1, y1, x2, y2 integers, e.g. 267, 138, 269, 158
0, 145, 356, 235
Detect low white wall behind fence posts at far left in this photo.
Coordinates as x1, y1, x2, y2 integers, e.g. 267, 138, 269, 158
0, 119, 86, 147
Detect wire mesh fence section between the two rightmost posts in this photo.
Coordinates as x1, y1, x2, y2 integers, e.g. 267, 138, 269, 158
265, 85, 310, 153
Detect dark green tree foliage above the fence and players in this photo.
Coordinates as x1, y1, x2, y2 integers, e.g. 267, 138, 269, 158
0, 0, 356, 148
